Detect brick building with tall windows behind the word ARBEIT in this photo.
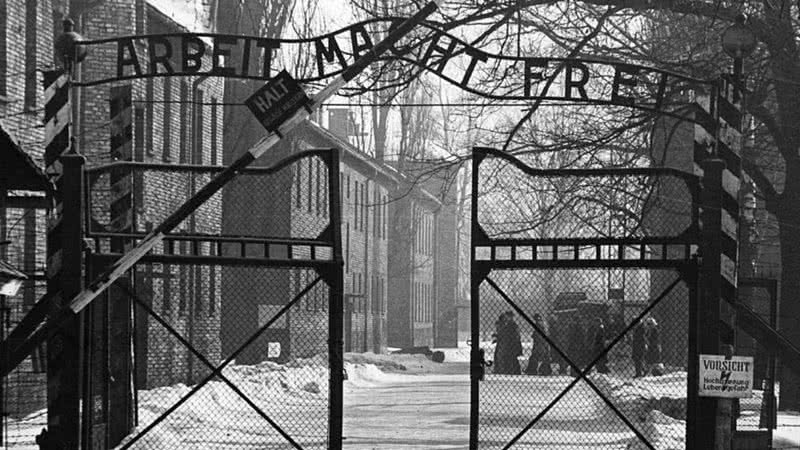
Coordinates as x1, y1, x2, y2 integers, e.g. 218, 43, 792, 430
78, 0, 224, 387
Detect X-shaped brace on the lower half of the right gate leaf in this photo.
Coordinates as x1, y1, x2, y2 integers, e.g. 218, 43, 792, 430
484, 276, 681, 450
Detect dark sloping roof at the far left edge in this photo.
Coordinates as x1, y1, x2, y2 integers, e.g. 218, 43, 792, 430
0, 120, 53, 191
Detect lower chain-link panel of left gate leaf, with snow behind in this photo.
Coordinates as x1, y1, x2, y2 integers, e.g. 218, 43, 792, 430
103, 264, 329, 449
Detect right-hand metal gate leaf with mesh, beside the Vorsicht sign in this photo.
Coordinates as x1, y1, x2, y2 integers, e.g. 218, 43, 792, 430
470, 148, 699, 449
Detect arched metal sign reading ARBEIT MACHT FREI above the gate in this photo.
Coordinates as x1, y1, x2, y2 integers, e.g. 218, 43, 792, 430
75, 18, 713, 114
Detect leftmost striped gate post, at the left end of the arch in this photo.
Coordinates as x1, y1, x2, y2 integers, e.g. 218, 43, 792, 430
41, 70, 85, 450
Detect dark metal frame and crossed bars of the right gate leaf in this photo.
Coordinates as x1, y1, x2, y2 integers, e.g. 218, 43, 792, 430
469, 148, 700, 449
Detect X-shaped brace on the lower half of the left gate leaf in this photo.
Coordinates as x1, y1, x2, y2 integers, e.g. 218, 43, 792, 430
117, 270, 323, 450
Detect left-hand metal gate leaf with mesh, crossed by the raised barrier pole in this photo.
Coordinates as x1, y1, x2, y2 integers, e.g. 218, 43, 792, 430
84, 150, 343, 449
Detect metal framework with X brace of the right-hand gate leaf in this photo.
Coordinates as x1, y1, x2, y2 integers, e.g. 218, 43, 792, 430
470, 148, 700, 449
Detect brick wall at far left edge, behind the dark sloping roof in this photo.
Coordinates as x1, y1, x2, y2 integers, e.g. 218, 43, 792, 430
0, 0, 61, 417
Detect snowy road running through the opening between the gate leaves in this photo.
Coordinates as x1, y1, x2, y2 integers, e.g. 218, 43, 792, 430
344, 363, 648, 450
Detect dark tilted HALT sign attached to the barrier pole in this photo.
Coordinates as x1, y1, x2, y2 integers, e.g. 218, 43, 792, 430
244, 70, 309, 131
